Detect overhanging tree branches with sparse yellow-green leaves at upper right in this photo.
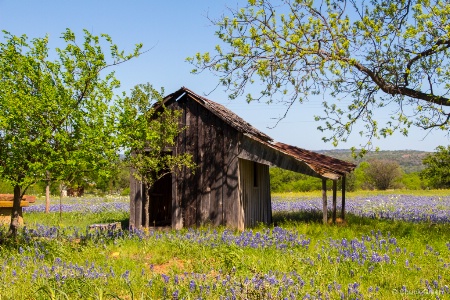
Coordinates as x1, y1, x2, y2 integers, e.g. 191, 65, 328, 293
188, 0, 450, 153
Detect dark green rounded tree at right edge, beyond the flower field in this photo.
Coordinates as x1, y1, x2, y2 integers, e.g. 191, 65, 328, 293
420, 146, 450, 189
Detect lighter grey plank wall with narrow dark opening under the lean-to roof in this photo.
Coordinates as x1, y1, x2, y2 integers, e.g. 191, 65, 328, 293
239, 159, 272, 228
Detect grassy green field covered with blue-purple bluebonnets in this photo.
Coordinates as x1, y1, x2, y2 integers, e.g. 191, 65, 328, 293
0, 191, 450, 299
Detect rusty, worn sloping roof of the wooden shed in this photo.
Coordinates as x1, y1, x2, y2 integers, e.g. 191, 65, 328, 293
165, 87, 356, 179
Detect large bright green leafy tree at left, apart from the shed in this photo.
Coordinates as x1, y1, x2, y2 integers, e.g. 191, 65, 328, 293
0, 29, 142, 235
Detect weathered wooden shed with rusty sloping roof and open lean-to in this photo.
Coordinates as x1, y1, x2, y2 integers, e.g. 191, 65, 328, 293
130, 87, 355, 230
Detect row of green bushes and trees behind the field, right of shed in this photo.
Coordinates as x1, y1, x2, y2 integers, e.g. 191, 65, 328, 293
270, 146, 450, 192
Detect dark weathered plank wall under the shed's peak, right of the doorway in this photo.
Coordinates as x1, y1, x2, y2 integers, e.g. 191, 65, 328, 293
168, 98, 240, 228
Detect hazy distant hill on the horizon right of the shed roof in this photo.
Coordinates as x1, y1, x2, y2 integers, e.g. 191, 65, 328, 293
316, 149, 431, 173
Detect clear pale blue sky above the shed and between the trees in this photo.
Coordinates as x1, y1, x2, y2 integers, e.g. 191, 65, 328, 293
0, 0, 450, 151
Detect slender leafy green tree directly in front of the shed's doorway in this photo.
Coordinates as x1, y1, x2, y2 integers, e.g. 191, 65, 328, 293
119, 83, 194, 227
